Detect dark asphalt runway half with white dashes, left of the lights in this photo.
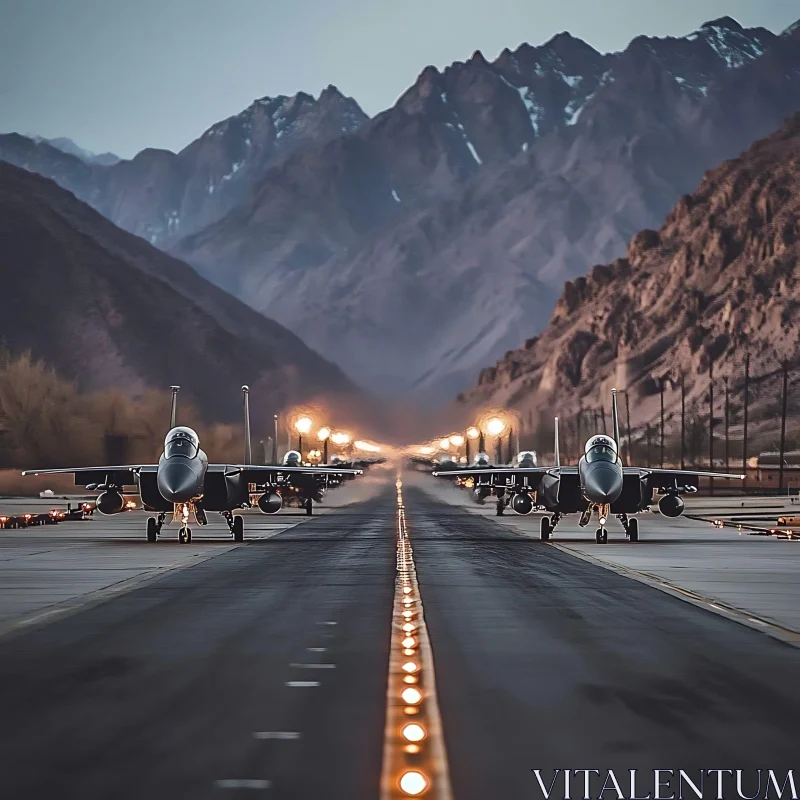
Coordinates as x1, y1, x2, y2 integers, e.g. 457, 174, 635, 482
0, 486, 395, 800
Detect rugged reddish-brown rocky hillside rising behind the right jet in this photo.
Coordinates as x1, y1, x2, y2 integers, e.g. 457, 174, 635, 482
461, 114, 800, 434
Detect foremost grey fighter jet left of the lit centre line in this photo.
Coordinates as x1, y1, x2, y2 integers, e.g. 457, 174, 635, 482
22, 386, 359, 544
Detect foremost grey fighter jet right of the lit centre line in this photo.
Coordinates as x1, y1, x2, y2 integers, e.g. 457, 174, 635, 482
433, 389, 745, 544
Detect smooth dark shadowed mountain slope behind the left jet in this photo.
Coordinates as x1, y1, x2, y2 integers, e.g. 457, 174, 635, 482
0, 162, 358, 422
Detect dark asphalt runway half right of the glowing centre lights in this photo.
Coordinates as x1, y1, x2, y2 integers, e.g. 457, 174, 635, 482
404, 488, 800, 800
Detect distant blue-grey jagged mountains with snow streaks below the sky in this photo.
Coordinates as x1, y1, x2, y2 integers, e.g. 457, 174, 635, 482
0, 17, 800, 406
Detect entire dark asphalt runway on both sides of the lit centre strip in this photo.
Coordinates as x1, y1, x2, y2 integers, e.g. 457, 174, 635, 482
0, 477, 800, 800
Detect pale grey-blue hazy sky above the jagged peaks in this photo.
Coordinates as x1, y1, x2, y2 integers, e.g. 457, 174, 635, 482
0, 0, 800, 157
